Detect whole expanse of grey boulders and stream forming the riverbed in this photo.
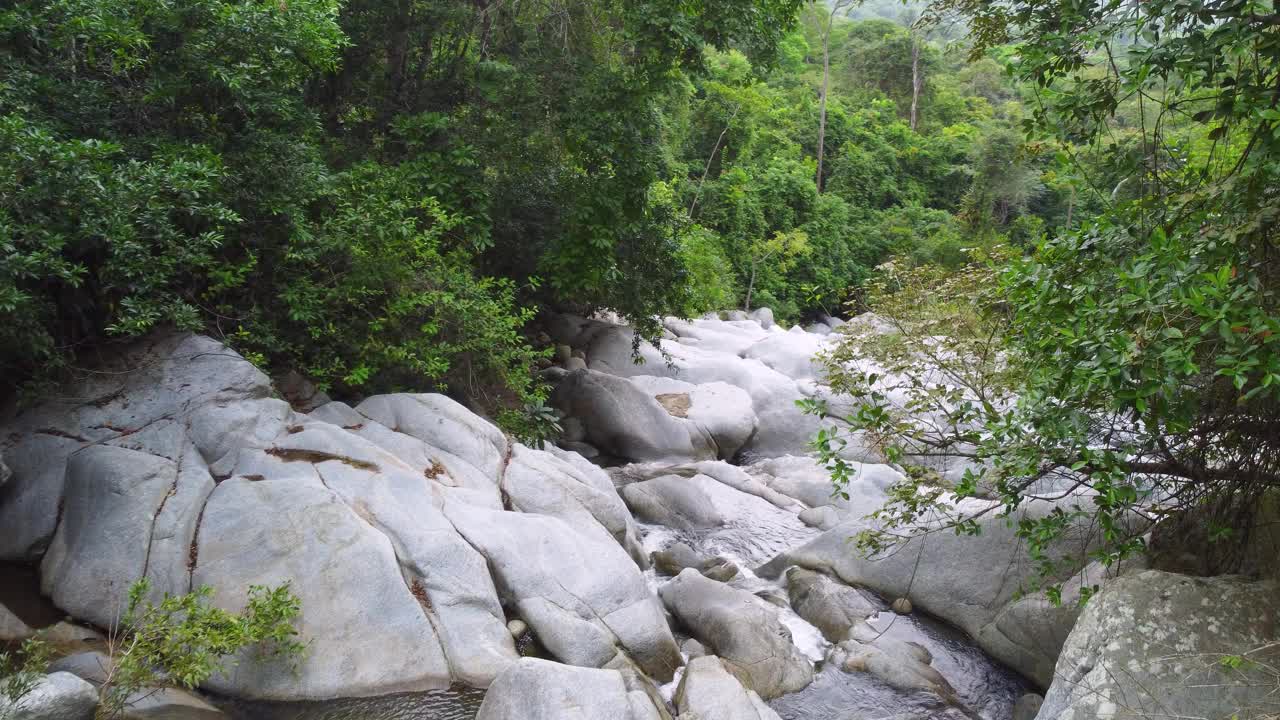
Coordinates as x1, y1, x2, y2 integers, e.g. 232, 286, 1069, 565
0, 310, 1275, 720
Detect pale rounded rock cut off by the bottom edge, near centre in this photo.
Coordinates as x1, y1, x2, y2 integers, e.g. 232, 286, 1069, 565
476, 657, 669, 720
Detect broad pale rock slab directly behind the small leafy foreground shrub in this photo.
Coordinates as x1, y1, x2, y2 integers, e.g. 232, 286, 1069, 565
192, 459, 460, 700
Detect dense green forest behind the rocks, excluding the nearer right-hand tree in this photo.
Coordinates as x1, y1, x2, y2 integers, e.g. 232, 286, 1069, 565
0, 0, 1059, 405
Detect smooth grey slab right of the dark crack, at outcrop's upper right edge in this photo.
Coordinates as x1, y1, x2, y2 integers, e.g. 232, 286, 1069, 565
502, 443, 645, 564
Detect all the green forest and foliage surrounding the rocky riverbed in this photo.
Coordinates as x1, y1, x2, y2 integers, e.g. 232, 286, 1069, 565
0, 0, 1280, 571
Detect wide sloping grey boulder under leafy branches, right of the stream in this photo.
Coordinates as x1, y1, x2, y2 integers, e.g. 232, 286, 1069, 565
758, 498, 1096, 684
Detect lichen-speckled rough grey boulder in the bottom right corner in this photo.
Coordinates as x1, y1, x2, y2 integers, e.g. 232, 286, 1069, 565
1037, 570, 1280, 720
